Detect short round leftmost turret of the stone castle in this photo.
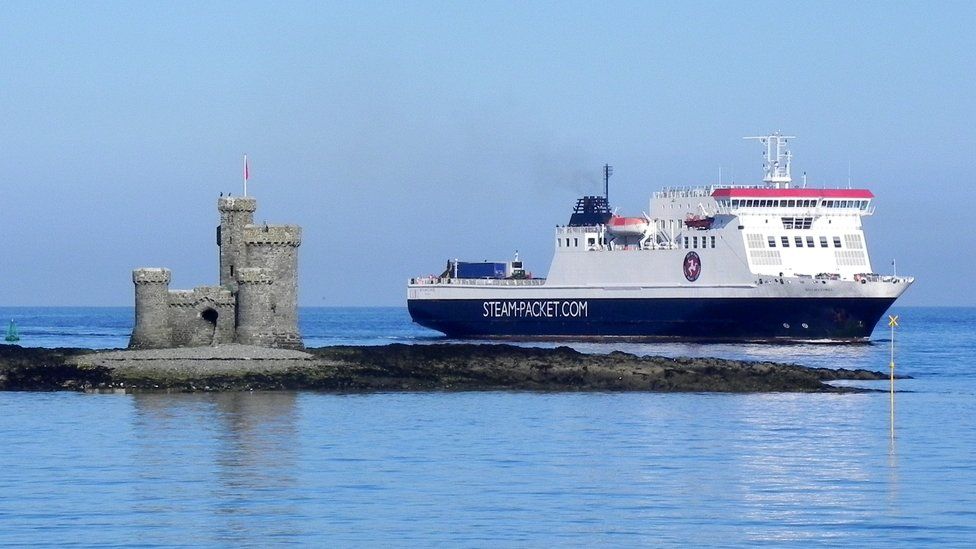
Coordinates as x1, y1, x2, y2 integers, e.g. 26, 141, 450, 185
129, 268, 172, 349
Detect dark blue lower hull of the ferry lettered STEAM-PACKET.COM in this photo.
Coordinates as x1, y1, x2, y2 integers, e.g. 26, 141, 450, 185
407, 298, 895, 341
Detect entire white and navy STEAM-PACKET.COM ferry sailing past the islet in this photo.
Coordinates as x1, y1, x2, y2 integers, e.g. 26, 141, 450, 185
407, 132, 914, 342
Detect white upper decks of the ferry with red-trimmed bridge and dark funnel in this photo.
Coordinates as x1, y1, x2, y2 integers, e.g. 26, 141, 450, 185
406, 134, 908, 286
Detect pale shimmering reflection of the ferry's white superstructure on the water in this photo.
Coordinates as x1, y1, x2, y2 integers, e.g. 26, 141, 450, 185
633, 394, 898, 545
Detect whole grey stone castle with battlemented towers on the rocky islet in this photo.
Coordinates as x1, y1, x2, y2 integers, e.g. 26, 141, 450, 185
129, 196, 303, 349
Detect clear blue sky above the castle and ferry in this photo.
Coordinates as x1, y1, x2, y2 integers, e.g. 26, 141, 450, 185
0, 1, 976, 306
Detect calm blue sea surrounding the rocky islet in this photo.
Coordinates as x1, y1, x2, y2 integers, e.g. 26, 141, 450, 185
0, 308, 976, 547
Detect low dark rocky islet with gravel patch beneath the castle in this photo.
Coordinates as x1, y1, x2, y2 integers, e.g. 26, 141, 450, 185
0, 344, 908, 392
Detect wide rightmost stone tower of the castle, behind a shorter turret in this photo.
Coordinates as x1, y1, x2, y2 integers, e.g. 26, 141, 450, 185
244, 225, 303, 349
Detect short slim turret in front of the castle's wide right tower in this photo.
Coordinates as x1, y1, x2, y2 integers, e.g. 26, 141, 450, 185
237, 267, 275, 347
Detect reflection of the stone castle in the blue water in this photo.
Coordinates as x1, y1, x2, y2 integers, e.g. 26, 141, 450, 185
132, 392, 303, 543
